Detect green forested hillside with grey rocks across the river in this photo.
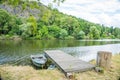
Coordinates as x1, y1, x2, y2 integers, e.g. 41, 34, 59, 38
0, 0, 120, 39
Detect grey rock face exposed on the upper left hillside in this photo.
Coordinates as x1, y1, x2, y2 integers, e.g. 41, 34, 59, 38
0, 4, 41, 18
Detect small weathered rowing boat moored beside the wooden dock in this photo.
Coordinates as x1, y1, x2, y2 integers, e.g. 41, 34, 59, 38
30, 54, 47, 67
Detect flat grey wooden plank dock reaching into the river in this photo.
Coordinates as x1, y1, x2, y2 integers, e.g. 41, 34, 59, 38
45, 50, 95, 74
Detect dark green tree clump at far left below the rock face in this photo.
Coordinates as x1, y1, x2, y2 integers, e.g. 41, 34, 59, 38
0, 9, 22, 35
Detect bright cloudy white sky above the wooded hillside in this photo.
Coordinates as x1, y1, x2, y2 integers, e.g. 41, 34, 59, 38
41, 0, 120, 27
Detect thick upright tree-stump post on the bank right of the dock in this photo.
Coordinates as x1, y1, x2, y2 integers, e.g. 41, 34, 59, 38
97, 51, 112, 69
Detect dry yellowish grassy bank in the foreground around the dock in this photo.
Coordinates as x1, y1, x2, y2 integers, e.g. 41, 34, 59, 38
0, 55, 120, 80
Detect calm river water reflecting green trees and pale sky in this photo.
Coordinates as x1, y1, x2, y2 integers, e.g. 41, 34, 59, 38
0, 40, 120, 65
